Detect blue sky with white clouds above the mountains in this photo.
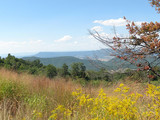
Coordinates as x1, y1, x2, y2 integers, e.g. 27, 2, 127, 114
0, 0, 160, 54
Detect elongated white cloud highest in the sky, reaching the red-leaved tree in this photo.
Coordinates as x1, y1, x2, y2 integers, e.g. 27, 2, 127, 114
93, 18, 142, 26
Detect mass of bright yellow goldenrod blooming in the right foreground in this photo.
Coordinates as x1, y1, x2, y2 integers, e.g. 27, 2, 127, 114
49, 84, 160, 120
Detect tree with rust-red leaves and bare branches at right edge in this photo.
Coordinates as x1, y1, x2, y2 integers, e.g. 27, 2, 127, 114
90, 0, 160, 83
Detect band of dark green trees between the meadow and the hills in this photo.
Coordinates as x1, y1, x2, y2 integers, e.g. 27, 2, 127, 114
0, 54, 155, 82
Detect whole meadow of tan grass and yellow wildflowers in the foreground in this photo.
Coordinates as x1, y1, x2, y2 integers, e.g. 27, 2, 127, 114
0, 68, 160, 120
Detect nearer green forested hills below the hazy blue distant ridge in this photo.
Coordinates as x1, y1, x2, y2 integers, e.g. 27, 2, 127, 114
23, 56, 139, 70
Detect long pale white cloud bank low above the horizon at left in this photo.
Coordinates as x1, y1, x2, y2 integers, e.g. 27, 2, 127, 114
0, 35, 106, 55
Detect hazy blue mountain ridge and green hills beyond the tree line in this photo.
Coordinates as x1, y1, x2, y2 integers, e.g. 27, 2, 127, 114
23, 49, 159, 70
